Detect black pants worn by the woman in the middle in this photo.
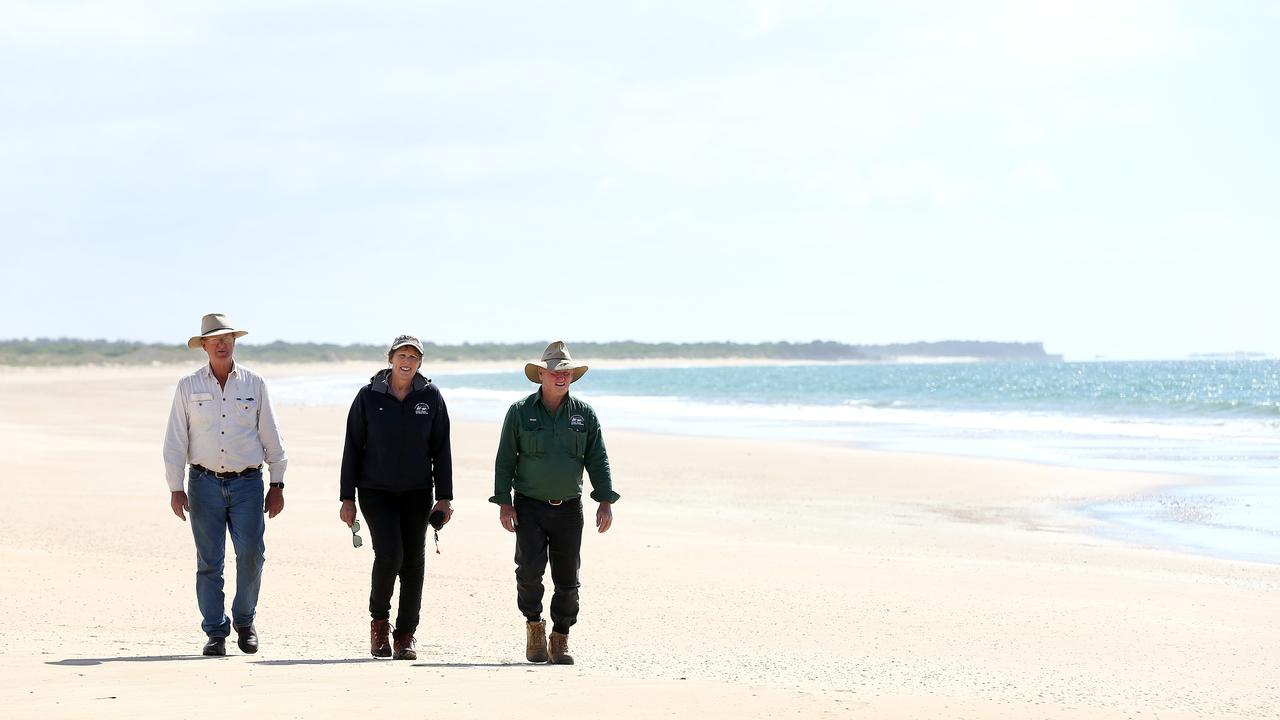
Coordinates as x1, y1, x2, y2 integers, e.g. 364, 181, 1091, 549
357, 488, 431, 633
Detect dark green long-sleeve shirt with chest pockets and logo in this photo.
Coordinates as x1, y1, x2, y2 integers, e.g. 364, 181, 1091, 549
489, 388, 620, 505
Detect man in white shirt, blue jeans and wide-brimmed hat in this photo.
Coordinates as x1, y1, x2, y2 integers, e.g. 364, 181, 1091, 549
164, 314, 288, 655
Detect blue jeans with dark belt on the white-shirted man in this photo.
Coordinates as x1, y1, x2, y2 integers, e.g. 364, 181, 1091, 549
187, 468, 266, 638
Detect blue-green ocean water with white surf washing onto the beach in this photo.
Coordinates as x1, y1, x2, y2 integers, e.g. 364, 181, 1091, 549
273, 360, 1280, 562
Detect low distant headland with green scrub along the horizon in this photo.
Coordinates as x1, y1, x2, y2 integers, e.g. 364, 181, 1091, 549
0, 338, 1062, 366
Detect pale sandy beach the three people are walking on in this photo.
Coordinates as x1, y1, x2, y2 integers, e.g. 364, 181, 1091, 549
0, 364, 1280, 720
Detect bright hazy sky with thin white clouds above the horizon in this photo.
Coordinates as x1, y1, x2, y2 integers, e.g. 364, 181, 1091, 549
0, 0, 1280, 359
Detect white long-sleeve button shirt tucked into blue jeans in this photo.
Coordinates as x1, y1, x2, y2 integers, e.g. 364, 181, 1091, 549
164, 364, 289, 492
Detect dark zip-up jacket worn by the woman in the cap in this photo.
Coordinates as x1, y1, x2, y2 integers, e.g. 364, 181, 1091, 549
338, 369, 453, 500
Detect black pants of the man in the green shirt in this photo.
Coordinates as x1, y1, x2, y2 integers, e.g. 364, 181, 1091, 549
516, 493, 582, 633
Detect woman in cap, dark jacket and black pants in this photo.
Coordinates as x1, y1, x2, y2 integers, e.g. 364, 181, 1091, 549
338, 336, 453, 660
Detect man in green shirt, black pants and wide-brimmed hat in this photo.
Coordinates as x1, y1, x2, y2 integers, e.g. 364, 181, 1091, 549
489, 341, 618, 665
